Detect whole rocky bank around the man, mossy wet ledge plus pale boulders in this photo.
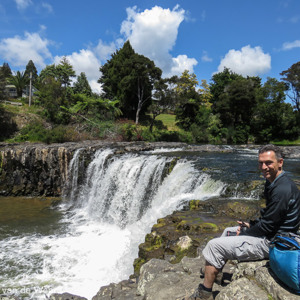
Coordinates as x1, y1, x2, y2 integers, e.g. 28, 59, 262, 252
50, 199, 299, 300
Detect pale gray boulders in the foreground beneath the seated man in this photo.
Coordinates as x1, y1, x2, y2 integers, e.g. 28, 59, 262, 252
89, 255, 299, 300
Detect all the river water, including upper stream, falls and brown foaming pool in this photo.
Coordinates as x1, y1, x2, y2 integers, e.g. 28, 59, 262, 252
0, 149, 300, 300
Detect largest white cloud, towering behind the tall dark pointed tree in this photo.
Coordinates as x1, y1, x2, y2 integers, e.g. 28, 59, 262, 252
121, 6, 197, 76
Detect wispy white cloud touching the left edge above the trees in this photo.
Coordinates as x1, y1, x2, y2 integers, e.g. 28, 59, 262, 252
0, 32, 52, 67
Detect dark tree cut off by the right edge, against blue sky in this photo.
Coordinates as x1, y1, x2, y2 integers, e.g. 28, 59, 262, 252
280, 61, 300, 112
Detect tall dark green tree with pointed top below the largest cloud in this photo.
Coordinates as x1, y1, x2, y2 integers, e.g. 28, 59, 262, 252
98, 41, 162, 123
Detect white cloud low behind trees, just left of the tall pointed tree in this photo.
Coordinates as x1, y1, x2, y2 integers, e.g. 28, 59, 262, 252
54, 49, 101, 93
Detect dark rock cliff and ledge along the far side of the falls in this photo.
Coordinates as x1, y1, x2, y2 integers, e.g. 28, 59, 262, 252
0, 141, 300, 196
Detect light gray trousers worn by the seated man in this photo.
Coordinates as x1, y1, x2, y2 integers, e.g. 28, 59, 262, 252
202, 226, 270, 269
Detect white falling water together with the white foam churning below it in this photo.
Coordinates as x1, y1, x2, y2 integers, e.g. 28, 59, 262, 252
0, 149, 224, 299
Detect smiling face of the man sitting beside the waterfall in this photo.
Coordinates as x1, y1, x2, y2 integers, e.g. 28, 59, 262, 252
258, 151, 283, 182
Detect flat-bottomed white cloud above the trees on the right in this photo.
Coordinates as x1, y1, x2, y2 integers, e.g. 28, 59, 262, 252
218, 45, 271, 76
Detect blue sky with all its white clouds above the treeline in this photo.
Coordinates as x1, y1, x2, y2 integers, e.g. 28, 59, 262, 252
0, 0, 300, 91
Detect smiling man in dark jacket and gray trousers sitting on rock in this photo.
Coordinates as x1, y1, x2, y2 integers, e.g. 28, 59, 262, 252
188, 145, 300, 299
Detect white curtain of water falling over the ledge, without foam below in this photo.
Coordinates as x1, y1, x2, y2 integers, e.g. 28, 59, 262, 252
65, 149, 224, 228
